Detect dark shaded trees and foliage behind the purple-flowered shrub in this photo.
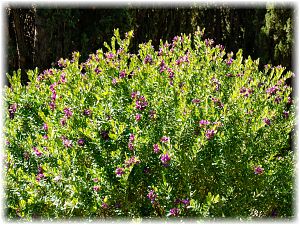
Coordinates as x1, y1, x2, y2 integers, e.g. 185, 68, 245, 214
6, 5, 294, 83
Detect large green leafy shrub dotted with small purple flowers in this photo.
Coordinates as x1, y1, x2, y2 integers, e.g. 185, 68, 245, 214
4, 29, 295, 220
